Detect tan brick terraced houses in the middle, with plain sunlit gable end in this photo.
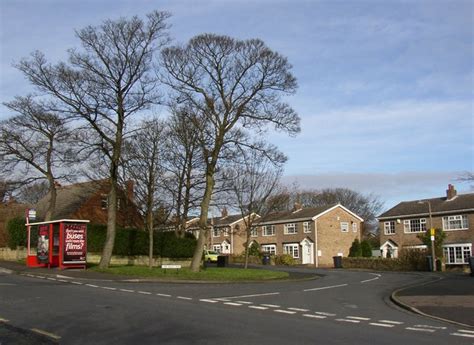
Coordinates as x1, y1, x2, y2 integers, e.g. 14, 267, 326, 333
207, 204, 363, 267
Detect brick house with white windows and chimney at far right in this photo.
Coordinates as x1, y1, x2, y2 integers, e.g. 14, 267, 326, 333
378, 185, 474, 265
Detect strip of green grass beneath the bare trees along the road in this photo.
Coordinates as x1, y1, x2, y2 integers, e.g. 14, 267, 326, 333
89, 266, 288, 281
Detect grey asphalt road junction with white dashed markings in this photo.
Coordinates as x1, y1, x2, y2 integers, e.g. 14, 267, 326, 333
0, 269, 474, 345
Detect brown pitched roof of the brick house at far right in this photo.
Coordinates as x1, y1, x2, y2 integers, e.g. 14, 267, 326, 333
377, 193, 474, 219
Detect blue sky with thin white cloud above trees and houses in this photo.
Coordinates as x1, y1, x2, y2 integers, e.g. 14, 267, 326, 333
0, 0, 474, 209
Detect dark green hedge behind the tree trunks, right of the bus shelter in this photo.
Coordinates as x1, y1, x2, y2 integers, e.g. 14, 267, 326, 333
87, 224, 196, 258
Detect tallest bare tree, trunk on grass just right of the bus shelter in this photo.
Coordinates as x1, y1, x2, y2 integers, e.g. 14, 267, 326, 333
17, 11, 169, 268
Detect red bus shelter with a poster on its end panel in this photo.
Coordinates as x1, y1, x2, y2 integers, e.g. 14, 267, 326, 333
26, 219, 89, 269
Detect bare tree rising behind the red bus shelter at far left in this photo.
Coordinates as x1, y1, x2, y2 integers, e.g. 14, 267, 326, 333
0, 96, 74, 220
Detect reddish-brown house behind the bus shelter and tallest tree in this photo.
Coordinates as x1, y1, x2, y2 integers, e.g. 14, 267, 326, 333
36, 180, 143, 228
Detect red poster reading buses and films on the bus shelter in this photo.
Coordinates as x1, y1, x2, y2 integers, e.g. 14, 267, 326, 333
63, 223, 87, 264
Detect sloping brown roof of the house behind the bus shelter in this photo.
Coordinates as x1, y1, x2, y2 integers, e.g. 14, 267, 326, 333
36, 180, 104, 219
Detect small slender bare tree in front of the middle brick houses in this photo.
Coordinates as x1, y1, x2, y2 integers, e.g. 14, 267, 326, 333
224, 149, 285, 268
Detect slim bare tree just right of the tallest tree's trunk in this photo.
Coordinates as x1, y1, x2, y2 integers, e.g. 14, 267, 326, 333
124, 118, 165, 268
